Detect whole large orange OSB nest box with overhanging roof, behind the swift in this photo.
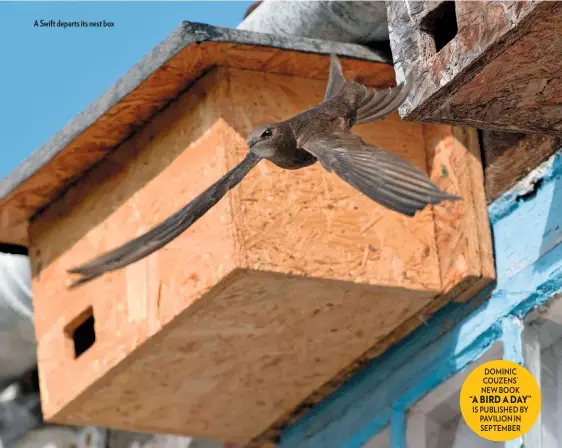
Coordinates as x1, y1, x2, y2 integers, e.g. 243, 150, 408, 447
0, 22, 494, 444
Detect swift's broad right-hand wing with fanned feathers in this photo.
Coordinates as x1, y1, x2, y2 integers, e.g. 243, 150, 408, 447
303, 131, 460, 216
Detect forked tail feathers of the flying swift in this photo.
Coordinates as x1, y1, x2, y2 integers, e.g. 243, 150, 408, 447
324, 54, 412, 124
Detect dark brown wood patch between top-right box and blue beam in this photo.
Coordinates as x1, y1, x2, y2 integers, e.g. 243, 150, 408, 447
482, 131, 562, 203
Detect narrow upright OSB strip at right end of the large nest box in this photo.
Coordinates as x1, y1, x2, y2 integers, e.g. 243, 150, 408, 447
424, 124, 495, 301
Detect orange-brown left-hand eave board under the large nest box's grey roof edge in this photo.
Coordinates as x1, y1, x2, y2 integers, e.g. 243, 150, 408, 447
0, 44, 218, 246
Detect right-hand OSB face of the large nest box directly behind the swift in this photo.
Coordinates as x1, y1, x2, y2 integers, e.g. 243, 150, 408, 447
224, 65, 441, 290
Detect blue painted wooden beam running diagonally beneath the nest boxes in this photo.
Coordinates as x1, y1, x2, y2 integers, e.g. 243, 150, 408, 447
280, 153, 562, 448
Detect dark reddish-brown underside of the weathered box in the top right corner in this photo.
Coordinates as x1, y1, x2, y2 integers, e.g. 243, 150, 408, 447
446, 2, 562, 136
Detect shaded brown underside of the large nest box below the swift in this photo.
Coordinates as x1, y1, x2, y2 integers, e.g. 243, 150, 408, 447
51, 271, 433, 444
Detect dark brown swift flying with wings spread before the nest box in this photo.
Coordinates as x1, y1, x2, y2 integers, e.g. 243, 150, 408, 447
68, 55, 460, 288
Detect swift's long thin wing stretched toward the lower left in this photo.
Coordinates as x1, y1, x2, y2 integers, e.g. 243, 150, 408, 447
68, 152, 261, 288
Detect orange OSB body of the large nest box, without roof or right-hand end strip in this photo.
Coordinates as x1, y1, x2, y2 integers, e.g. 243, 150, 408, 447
30, 67, 485, 446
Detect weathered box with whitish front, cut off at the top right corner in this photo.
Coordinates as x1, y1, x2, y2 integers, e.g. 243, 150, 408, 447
387, 0, 562, 136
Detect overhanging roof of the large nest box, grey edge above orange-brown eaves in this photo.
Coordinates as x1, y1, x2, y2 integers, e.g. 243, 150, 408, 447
0, 22, 394, 245
